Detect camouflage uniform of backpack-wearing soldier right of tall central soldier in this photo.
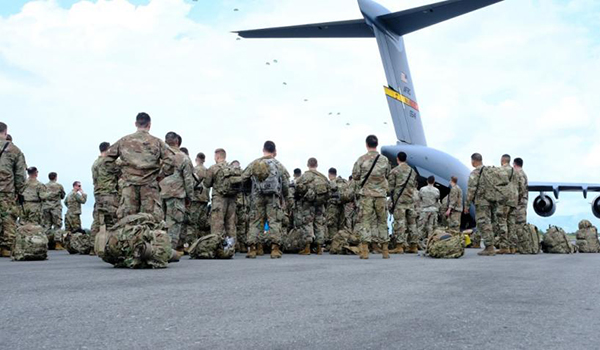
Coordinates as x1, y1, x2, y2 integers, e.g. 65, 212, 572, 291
296, 169, 329, 246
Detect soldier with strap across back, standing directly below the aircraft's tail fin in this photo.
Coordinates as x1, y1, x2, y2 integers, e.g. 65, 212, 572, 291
388, 152, 419, 254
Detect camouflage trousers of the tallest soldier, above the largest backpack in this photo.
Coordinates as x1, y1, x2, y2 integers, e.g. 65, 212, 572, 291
117, 183, 164, 221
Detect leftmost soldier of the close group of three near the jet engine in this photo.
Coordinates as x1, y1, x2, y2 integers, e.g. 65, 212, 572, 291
463, 153, 496, 256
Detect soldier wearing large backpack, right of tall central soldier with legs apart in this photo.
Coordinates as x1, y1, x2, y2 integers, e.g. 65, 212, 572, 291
296, 158, 329, 255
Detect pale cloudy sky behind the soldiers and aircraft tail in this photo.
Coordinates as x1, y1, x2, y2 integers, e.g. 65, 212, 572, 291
0, 0, 600, 231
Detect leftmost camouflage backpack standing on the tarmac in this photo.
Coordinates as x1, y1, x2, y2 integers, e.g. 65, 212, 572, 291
11, 224, 48, 261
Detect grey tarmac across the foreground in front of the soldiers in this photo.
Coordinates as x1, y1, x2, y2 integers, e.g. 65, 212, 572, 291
0, 250, 600, 349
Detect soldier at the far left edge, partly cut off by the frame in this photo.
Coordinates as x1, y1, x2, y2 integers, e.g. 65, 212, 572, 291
0, 122, 27, 258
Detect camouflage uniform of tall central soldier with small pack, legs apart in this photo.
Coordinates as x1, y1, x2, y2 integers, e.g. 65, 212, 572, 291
242, 156, 290, 246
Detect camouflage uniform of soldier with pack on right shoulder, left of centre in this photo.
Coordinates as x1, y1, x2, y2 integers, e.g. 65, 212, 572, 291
204, 160, 237, 240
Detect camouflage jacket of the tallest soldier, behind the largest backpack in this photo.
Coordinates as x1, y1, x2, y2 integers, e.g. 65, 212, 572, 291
108, 130, 175, 186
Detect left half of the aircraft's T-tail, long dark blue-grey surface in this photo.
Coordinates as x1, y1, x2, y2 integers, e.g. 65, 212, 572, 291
234, 19, 375, 39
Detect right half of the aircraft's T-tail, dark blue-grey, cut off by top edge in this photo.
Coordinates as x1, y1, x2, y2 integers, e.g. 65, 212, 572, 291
377, 0, 503, 36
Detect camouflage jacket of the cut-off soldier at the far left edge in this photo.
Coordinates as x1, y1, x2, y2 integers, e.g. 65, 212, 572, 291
0, 140, 27, 194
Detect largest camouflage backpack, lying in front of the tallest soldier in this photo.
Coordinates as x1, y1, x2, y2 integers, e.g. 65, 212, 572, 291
102, 213, 175, 269
